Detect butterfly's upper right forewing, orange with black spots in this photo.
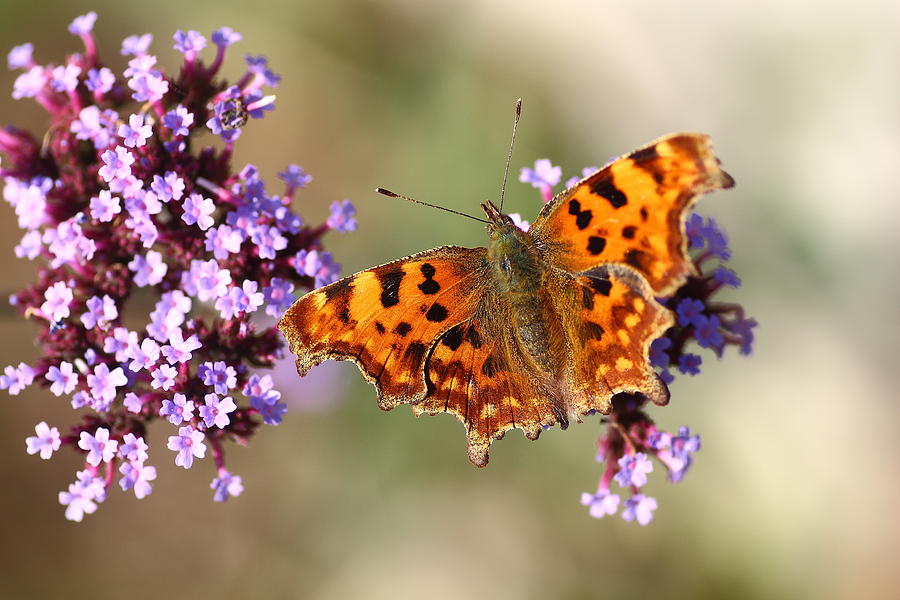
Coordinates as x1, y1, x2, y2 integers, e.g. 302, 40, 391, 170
531, 133, 734, 296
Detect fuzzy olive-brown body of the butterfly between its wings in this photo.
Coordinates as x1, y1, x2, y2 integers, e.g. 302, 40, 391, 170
482, 203, 558, 374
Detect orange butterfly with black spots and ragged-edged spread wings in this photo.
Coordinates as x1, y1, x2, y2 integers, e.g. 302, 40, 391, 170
278, 133, 734, 467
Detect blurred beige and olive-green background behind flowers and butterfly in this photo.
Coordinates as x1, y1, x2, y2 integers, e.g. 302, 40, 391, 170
0, 0, 900, 598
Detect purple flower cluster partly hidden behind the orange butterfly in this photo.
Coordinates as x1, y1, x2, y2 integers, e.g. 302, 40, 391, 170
520, 159, 756, 525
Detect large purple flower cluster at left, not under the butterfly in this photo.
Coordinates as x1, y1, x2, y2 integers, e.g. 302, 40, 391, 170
0, 13, 356, 521
